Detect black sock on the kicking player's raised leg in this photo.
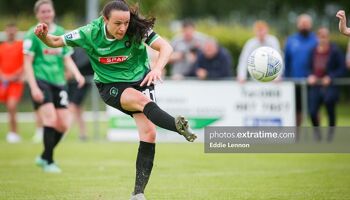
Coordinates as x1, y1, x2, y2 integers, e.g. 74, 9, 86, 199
143, 101, 178, 132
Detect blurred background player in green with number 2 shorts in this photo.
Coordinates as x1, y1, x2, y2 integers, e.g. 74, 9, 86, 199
23, 0, 85, 173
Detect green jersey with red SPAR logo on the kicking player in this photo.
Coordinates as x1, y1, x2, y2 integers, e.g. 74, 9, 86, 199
62, 17, 159, 83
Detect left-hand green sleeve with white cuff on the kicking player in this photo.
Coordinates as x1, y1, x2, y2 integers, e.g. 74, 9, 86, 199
61, 25, 92, 49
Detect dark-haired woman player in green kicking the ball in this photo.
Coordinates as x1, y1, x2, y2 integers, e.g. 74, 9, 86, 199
35, 0, 197, 199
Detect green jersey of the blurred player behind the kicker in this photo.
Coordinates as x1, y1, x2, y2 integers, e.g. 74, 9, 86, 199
23, 24, 73, 85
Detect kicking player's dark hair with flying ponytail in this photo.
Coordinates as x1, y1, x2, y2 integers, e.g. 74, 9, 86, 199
102, 0, 156, 43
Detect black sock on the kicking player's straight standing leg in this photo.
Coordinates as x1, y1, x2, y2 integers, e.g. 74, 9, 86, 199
134, 141, 156, 194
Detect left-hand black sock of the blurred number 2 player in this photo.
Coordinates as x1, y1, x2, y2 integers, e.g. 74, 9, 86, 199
41, 126, 56, 164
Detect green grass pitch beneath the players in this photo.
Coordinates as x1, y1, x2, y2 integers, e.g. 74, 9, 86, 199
0, 121, 350, 200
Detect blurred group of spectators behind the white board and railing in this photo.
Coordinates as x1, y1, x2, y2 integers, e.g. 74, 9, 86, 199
166, 14, 350, 134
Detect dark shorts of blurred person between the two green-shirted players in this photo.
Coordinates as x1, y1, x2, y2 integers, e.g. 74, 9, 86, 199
68, 81, 91, 106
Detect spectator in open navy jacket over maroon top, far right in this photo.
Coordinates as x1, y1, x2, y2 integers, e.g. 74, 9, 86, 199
308, 28, 345, 133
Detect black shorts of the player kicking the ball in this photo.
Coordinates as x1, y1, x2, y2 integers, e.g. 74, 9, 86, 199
96, 79, 156, 116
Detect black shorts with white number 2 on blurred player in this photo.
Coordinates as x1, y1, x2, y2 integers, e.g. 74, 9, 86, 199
32, 80, 68, 110
